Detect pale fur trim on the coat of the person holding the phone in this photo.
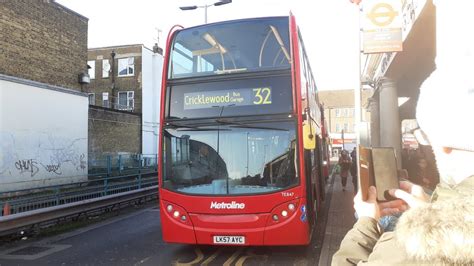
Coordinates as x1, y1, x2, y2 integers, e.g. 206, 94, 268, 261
395, 194, 474, 264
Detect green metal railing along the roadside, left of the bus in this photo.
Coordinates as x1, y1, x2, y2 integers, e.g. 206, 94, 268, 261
0, 154, 158, 216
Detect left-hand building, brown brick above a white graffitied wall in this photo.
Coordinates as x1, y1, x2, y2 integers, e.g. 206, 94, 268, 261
0, 0, 88, 192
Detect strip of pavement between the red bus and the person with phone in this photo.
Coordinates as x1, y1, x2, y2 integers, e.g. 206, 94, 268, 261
319, 169, 356, 266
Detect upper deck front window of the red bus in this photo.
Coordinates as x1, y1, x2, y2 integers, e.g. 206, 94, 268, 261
169, 17, 291, 79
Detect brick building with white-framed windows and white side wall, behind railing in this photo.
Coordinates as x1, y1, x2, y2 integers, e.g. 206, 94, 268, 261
84, 44, 163, 157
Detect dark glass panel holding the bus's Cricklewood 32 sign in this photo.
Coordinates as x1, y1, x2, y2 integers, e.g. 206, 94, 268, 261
166, 75, 293, 119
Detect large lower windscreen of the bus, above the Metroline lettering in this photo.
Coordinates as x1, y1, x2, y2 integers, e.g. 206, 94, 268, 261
163, 119, 299, 195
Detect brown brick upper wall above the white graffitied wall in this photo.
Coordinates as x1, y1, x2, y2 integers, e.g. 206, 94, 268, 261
0, 0, 88, 90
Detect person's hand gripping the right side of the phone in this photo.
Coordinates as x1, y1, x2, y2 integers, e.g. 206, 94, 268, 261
389, 181, 430, 208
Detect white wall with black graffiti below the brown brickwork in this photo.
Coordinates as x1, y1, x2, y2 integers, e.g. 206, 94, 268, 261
0, 80, 88, 192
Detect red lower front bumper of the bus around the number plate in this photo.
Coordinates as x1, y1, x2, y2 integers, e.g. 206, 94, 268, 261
160, 200, 311, 246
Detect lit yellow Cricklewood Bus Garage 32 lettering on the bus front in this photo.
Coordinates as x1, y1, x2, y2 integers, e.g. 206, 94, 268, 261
183, 87, 272, 110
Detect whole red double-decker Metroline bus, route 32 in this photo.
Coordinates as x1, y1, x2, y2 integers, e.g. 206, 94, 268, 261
158, 16, 324, 246
